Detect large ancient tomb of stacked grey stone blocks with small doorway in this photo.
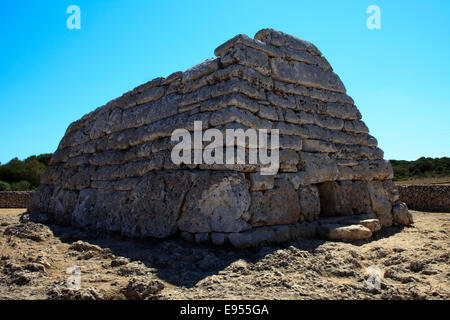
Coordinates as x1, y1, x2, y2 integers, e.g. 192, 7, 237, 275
29, 29, 412, 247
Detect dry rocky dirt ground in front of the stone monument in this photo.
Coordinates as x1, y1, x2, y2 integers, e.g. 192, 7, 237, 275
0, 209, 450, 300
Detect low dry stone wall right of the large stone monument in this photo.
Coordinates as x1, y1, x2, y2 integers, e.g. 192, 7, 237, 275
398, 185, 450, 212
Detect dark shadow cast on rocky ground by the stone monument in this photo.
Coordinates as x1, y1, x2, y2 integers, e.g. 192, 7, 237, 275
43, 218, 402, 288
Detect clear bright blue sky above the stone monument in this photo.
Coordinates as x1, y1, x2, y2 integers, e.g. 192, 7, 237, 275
0, 0, 450, 163
